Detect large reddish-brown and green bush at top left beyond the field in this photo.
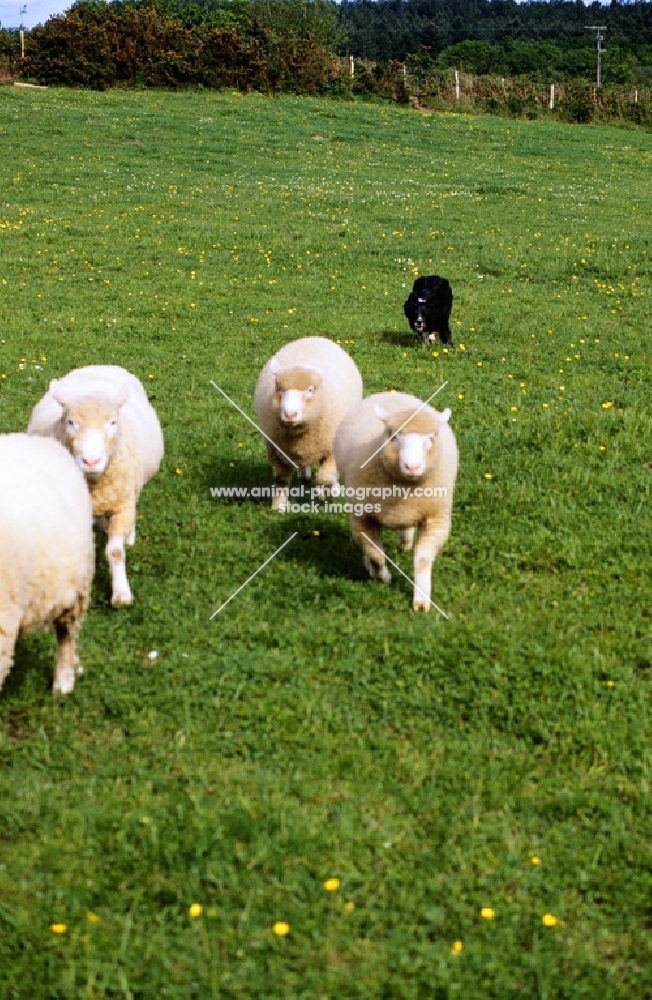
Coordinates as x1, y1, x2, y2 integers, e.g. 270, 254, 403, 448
25, 3, 336, 92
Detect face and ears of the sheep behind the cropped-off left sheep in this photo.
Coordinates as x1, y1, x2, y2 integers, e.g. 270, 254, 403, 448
53, 386, 129, 479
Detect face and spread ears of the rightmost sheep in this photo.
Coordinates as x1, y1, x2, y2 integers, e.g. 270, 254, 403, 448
376, 406, 450, 482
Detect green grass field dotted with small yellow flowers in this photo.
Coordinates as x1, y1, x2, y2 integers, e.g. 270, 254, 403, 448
0, 88, 652, 1000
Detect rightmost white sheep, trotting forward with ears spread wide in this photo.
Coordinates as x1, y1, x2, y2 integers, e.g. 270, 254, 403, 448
334, 392, 458, 611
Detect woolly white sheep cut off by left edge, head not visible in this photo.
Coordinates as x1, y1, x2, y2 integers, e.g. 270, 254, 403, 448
0, 434, 94, 694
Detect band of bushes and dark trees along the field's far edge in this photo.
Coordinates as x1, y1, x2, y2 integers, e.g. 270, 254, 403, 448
0, 0, 652, 94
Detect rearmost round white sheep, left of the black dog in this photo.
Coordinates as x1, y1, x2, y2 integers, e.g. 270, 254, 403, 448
255, 337, 362, 510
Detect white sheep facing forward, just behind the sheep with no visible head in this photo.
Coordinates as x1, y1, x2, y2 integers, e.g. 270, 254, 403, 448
27, 365, 163, 607
